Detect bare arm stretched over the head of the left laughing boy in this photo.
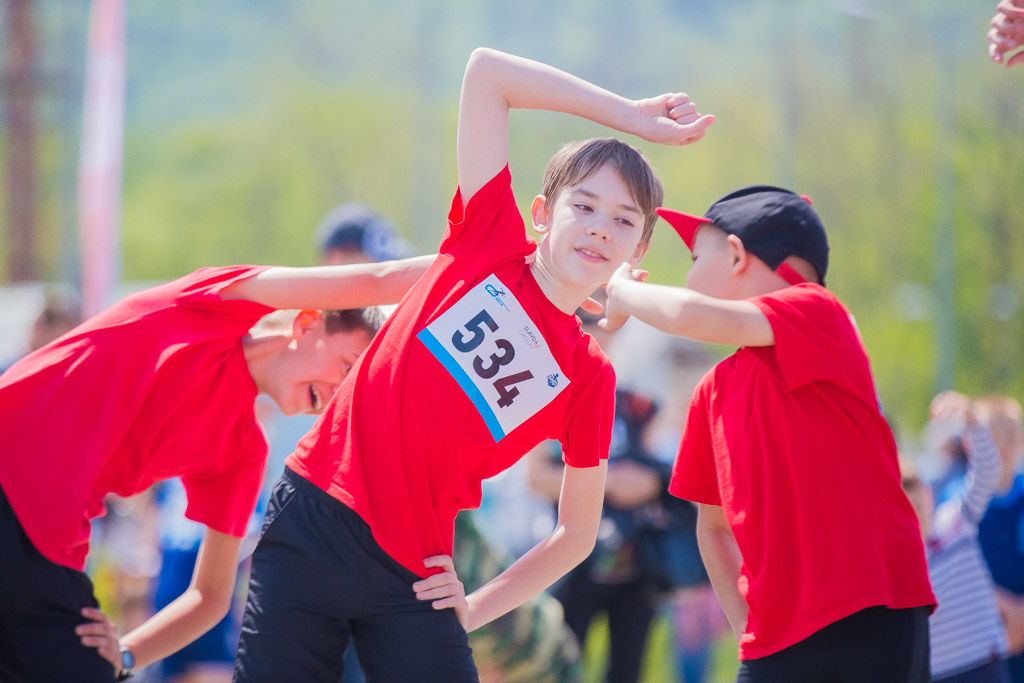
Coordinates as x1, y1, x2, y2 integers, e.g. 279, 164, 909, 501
221, 254, 435, 310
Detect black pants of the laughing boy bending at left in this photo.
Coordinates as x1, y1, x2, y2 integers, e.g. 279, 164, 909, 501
0, 483, 116, 683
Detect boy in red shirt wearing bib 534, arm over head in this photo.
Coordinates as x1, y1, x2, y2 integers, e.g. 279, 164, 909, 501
236, 49, 712, 683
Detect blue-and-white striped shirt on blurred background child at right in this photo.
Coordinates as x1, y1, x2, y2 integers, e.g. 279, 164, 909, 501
926, 425, 1007, 679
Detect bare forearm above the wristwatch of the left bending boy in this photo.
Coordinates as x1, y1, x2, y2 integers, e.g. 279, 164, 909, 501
121, 588, 230, 667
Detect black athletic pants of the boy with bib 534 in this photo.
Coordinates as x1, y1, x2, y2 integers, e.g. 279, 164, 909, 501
234, 469, 478, 683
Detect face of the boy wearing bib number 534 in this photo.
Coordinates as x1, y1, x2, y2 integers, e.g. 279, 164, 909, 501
534, 165, 645, 291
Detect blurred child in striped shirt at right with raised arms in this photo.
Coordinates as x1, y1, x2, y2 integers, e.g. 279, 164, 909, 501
900, 391, 1010, 683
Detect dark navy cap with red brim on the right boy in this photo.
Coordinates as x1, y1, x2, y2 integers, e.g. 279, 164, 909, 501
657, 185, 828, 285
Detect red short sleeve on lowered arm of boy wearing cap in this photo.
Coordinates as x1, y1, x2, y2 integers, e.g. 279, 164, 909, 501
669, 380, 722, 505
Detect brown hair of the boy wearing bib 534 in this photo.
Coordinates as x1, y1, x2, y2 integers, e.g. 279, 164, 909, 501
541, 137, 665, 247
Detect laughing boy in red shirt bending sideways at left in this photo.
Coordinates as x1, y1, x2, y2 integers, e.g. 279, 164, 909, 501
0, 257, 433, 681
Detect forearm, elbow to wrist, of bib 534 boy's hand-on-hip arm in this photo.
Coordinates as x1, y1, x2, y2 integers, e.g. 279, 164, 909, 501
466, 526, 595, 631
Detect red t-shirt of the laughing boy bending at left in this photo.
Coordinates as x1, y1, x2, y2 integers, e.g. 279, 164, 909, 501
0, 266, 272, 570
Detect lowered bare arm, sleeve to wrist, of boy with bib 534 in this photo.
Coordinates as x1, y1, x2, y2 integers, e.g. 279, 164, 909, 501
466, 460, 608, 631
